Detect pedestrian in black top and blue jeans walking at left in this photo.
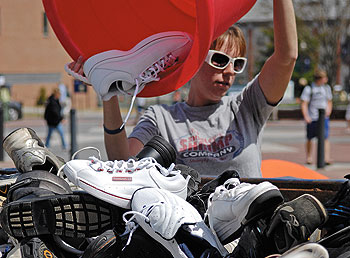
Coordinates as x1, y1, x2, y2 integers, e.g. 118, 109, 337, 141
44, 88, 67, 150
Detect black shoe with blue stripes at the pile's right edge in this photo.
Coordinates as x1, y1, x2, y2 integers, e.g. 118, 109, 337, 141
324, 180, 350, 235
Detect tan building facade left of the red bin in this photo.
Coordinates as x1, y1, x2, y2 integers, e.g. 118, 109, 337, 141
0, 0, 98, 109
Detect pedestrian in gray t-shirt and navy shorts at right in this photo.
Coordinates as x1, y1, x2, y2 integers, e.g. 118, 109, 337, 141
300, 69, 333, 165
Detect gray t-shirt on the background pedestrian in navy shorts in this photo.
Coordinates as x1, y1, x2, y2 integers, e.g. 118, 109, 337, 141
300, 83, 332, 121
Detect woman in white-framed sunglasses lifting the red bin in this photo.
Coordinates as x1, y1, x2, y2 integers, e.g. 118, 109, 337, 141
70, 0, 298, 177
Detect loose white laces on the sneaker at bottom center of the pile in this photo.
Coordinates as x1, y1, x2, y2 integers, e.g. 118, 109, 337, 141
122, 202, 163, 250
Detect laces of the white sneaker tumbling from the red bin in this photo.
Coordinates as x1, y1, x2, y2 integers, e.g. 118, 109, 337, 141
118, 53, 178, 129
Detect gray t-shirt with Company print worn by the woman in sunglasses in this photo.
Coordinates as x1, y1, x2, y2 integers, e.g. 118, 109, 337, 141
129, 77, 274, 177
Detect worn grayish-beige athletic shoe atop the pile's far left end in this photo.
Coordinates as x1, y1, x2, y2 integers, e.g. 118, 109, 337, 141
3, 128, 64, 174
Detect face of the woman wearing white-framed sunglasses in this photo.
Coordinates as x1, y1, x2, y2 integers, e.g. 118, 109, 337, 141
190, 40, 239, 106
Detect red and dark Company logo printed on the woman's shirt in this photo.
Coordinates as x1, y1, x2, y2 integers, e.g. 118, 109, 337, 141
177, 130, 244, 161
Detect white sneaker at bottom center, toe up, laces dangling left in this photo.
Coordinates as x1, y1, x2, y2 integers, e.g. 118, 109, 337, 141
123, 188, 228, 257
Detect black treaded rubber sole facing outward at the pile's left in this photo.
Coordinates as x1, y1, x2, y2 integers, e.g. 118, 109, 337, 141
0, 192, 125, 239
